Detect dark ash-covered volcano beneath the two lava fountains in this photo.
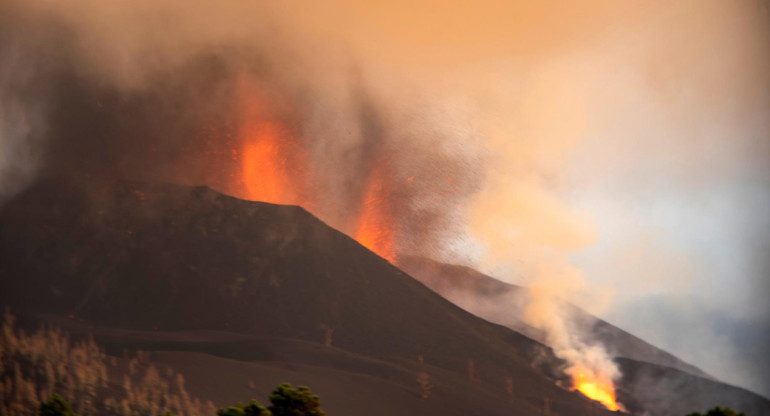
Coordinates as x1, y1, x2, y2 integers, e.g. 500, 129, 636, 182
0, 177, 770, 416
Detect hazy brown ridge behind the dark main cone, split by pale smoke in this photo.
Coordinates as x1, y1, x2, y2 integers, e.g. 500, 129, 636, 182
399, 256, 711, 378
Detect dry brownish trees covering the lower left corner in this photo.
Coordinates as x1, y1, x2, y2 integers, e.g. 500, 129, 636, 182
0, 311, 216, 416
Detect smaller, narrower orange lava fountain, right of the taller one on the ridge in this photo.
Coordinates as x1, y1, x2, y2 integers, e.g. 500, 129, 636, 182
355, 172, 396, 262
